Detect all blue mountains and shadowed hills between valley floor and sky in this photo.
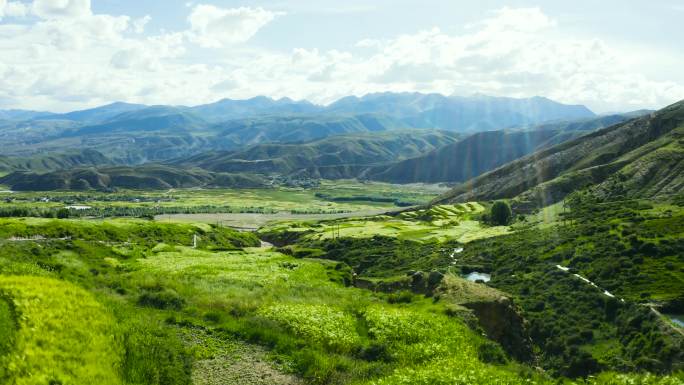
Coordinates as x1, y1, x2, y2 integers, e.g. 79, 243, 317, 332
0, 93, 664, 190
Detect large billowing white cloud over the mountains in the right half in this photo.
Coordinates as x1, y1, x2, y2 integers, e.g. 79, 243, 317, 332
284, 8, 684, 110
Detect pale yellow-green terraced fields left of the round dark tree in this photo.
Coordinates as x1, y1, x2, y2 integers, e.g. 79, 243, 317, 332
260, 202, 510, 243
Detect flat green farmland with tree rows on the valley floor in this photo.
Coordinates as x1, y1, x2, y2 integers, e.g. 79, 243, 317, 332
0, 181, 444, 228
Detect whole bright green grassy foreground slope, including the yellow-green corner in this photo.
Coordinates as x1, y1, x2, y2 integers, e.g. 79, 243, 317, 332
0, 214, 681, 385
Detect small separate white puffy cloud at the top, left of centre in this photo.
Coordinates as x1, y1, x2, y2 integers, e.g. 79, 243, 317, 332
188, 4, 278, 48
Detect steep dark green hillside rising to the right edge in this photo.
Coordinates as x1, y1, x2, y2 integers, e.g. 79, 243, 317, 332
437, 101, 684, 204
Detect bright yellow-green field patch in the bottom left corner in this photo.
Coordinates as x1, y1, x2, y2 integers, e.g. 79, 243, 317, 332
0, 276, 121, 385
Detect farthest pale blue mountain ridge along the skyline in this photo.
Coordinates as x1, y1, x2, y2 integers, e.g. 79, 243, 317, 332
0, 92, 595, 124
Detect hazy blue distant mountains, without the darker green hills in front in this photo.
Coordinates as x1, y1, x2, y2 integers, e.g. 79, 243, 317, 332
0, 93, 594, 165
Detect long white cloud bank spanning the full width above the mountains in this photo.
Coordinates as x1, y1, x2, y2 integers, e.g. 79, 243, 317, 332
0, 4, 684, 111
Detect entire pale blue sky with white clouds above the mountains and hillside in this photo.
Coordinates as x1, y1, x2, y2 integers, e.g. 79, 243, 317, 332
0, 0, 684, 113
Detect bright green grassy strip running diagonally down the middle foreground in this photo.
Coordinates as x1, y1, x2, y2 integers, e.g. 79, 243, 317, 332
129, 244, 528, 384
